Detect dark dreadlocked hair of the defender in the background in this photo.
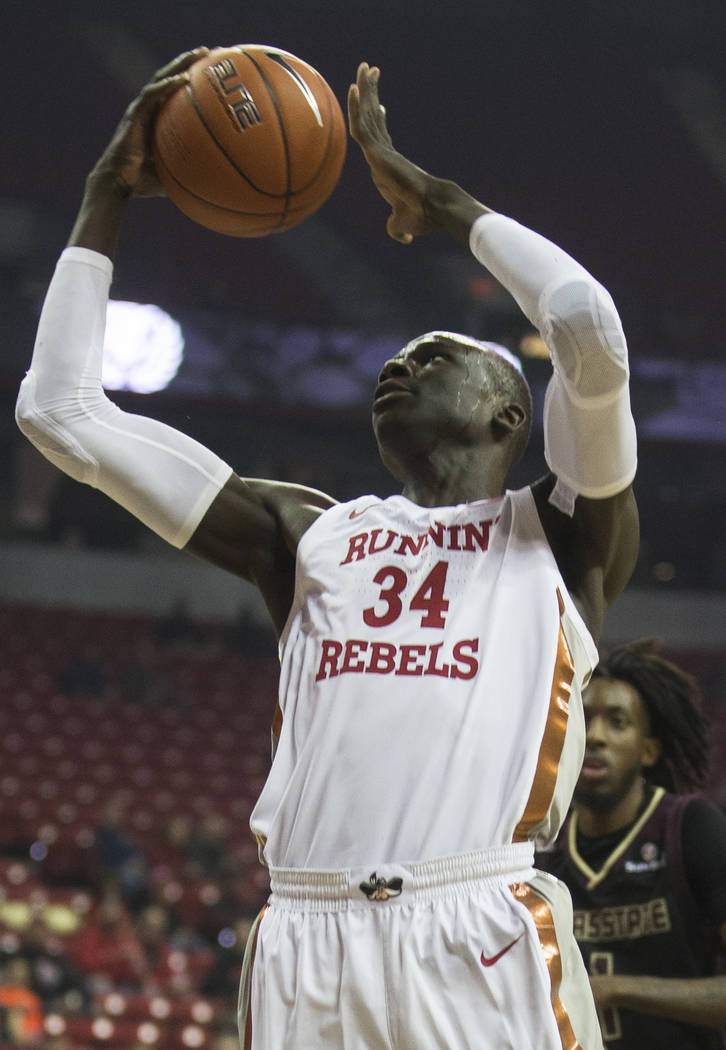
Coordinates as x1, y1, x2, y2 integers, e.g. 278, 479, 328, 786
593, 638, 708, 792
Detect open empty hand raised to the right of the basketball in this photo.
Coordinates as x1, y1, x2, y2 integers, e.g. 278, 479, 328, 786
348, 62, 439, 245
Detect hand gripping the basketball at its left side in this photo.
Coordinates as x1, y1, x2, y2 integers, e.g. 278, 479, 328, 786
91, 47, 209, 196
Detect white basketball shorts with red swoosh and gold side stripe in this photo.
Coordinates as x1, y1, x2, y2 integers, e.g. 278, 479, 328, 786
240, 843, 602, 1050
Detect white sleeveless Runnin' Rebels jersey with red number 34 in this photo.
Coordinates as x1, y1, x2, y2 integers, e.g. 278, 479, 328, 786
251, 488, 597, 869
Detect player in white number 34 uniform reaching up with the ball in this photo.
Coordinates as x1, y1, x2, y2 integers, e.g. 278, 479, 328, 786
18, 53, 638, 1050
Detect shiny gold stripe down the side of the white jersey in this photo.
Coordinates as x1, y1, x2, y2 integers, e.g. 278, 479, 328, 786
513, 589, 575, 842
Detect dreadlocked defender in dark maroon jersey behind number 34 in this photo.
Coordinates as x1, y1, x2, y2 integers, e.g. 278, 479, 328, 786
538, 641, 726, 1050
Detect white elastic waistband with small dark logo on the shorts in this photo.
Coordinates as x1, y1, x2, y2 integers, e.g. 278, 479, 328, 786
270, 842, 535, 908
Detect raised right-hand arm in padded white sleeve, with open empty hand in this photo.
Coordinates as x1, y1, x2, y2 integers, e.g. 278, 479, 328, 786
349, 63, 638, 634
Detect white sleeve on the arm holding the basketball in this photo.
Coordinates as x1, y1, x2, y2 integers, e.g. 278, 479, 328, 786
16, 248, 232, 547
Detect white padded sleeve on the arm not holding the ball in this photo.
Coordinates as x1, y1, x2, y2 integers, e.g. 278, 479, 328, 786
470, 212, 637, 515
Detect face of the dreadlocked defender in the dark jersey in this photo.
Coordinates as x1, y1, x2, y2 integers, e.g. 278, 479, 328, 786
575, 678, 658, 813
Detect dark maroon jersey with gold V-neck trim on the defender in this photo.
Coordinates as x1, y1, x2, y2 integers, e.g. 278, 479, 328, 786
537, 788, 726, 1050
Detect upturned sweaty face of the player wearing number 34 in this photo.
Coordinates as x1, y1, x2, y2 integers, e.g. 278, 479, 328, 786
372, 336, 498, 474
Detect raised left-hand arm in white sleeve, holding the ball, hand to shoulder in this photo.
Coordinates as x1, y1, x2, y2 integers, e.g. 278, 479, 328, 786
16, 48, 332, 624
